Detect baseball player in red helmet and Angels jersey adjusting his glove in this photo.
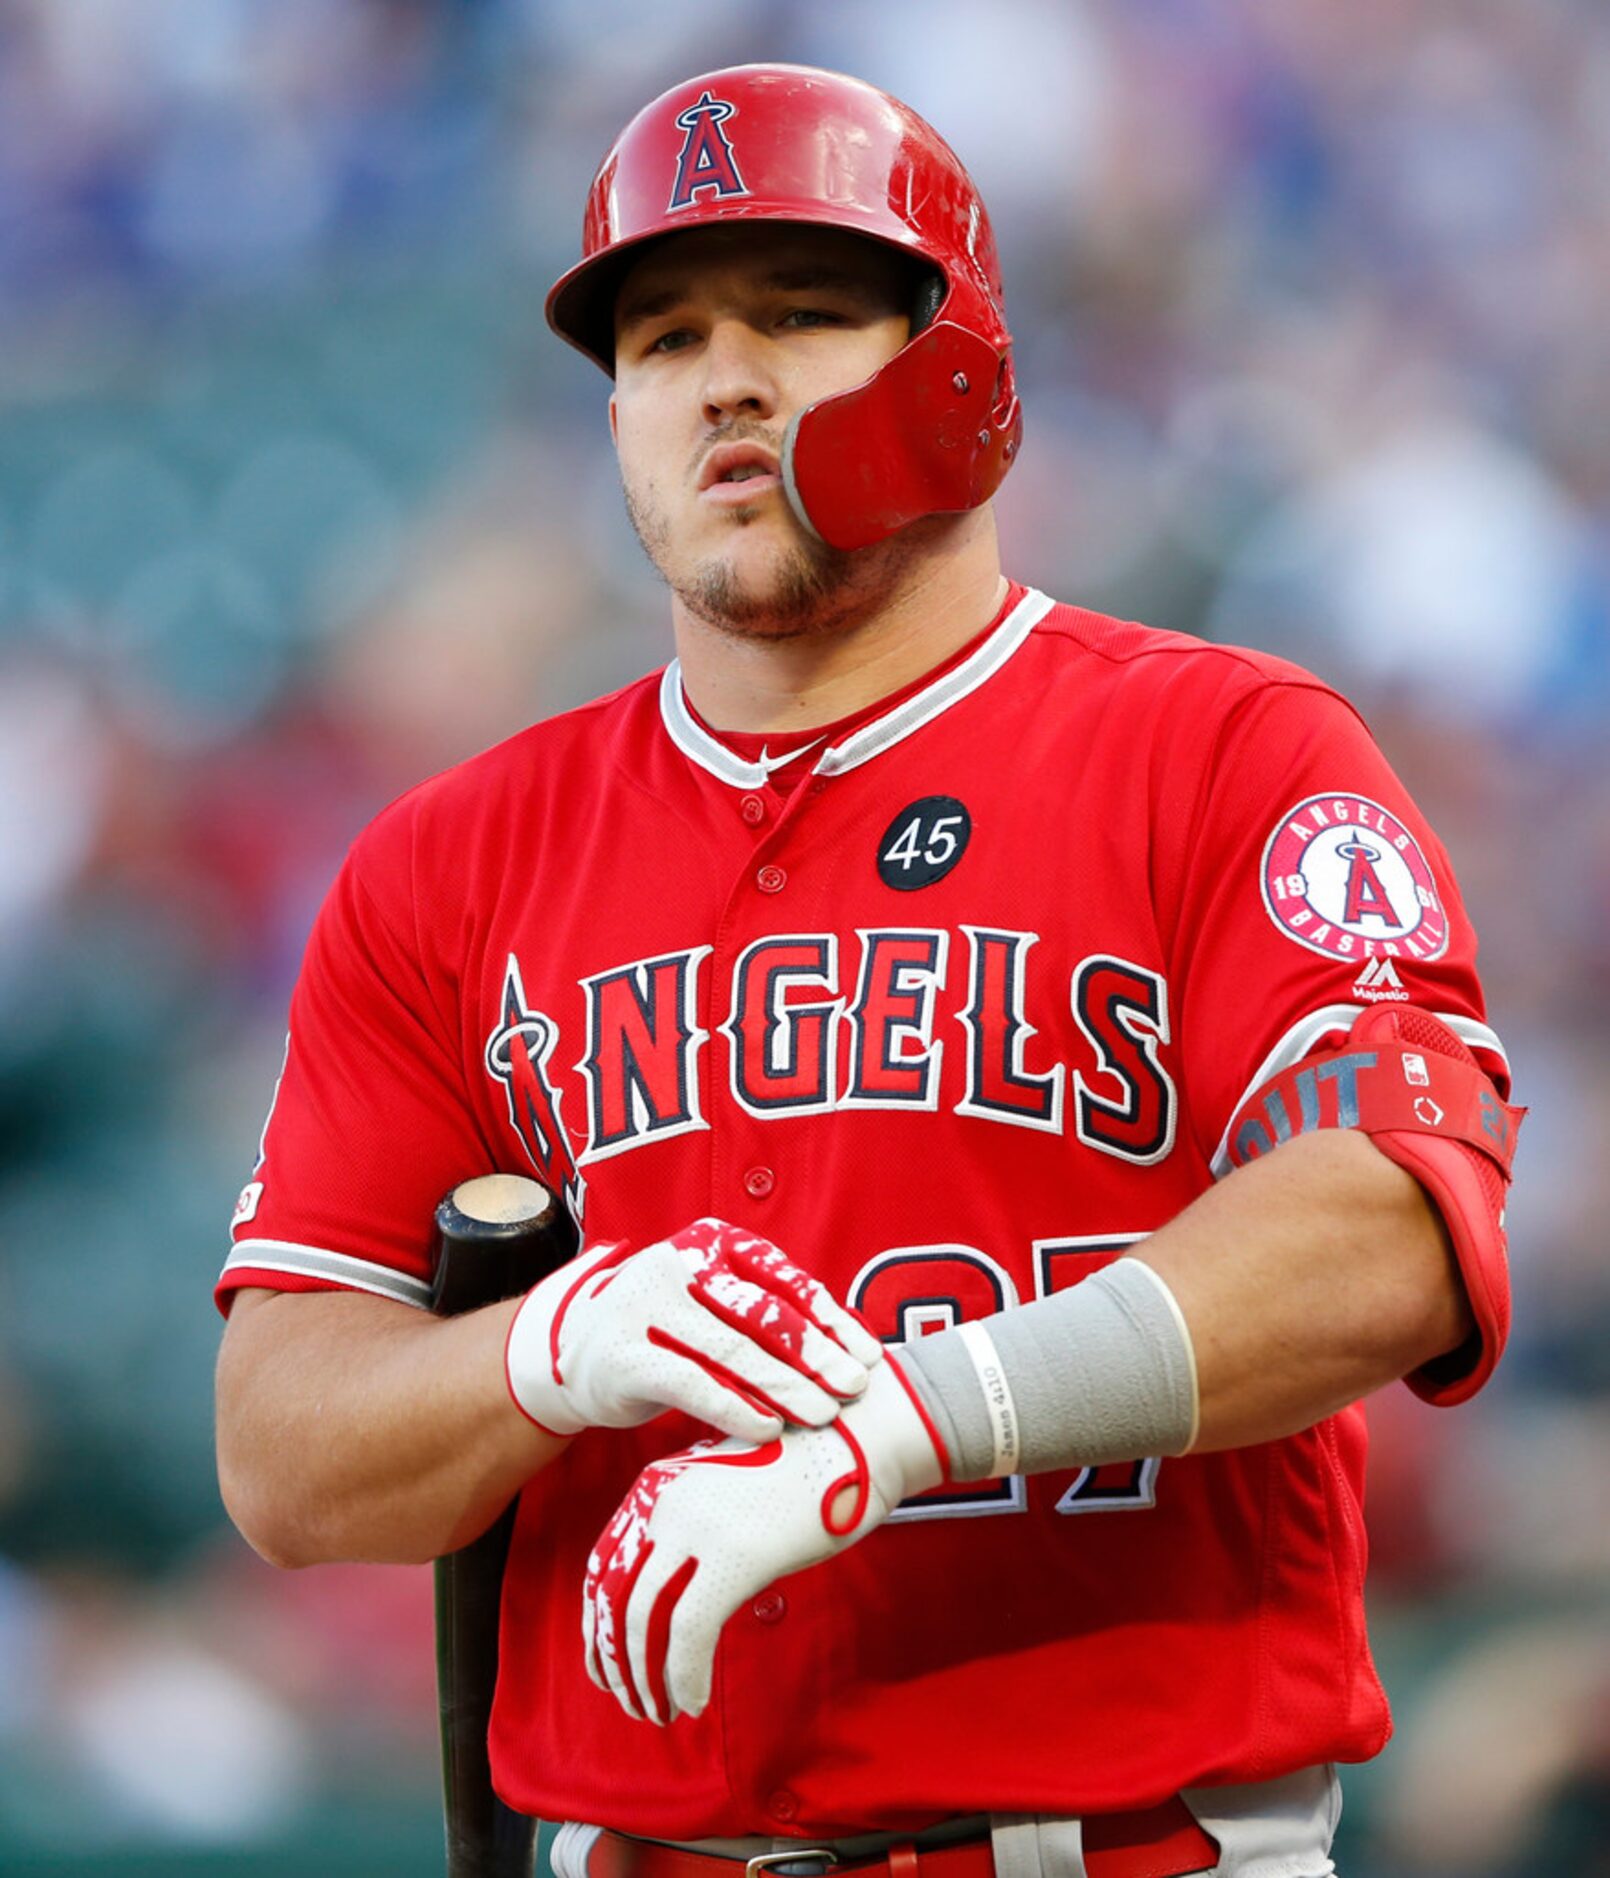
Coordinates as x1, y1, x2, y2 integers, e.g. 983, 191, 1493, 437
220, 66, 1518, 1878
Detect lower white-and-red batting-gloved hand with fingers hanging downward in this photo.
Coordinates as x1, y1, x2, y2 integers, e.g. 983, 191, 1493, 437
582, 1356, 947, 1724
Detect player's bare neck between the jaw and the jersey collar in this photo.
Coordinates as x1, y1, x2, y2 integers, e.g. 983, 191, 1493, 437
674, 530, 1007, 734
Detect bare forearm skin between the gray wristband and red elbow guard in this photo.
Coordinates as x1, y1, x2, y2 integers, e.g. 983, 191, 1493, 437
1137, 1129, 1471, 1452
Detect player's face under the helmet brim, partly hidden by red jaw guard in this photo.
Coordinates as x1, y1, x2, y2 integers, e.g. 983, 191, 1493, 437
611, 223, 911, 639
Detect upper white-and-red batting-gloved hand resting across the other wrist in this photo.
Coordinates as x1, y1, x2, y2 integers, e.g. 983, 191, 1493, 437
505, 1219, 883, 1440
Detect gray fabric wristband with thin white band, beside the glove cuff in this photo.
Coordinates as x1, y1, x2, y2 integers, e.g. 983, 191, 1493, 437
902, 1258, 1199, 1480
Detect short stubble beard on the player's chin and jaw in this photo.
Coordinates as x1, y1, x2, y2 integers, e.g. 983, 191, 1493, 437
626, 473, 906, 640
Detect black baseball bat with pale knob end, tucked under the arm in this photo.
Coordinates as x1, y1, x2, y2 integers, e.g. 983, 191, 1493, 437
430, 1174, 577, 1878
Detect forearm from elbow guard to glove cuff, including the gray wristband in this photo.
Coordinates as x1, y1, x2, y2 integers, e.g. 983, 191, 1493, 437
906, 1131, 1469, 1480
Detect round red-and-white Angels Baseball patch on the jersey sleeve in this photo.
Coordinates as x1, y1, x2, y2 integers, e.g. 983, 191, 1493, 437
1262, 794, 1448, 960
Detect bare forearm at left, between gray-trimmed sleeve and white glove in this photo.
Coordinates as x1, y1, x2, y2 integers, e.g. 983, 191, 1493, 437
218, 1292, 564, 1566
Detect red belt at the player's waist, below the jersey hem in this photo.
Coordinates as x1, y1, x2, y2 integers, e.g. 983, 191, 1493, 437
586, 1797, 1219, 1878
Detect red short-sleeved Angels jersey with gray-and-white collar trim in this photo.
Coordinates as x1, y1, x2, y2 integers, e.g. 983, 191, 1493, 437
220, 588, 1505, 1839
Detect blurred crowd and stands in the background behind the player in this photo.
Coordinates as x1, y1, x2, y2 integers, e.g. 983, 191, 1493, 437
0, 0, 1610, 1878
